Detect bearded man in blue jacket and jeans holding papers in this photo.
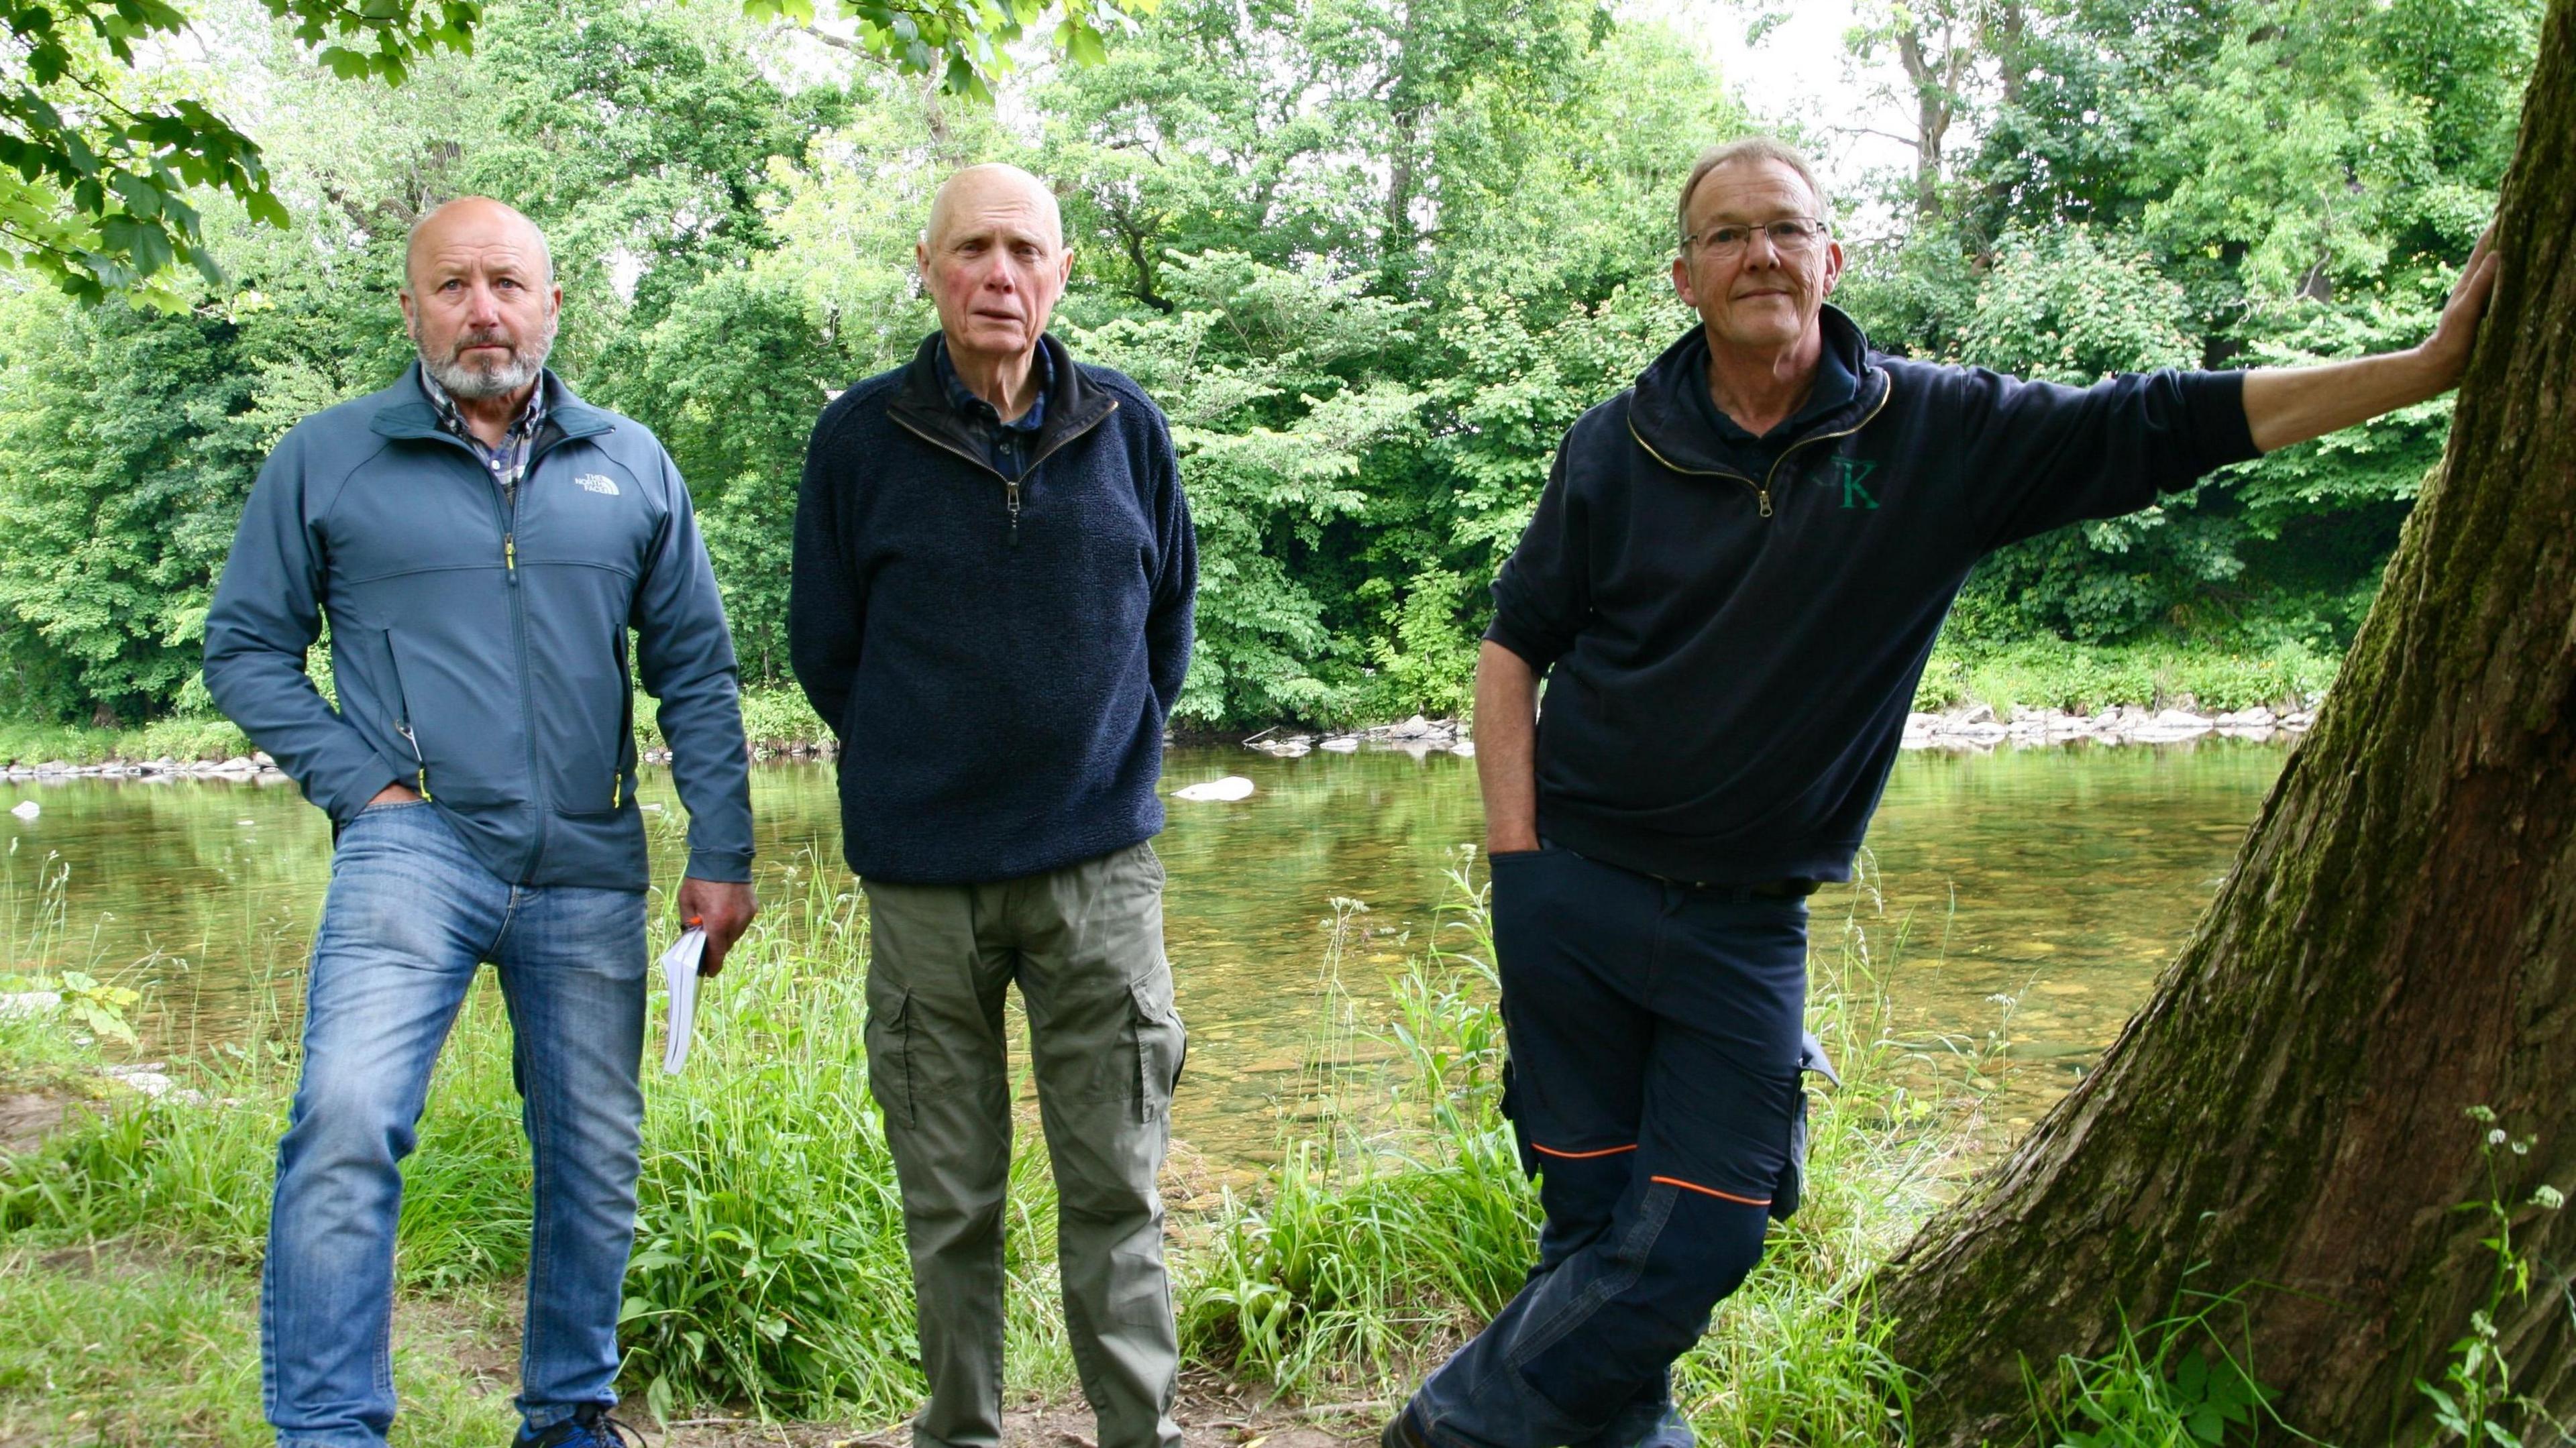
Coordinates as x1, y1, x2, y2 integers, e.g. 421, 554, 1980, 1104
206, 199, 755, 1448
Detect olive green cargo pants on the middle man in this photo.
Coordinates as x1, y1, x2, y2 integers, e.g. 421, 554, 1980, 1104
865, 845, 1183, 1448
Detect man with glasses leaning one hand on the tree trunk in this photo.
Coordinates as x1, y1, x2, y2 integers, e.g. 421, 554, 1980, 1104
1383, 139, 2493, 1448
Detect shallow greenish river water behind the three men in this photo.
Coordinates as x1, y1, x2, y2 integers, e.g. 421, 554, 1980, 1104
0, 740, 2288, 1167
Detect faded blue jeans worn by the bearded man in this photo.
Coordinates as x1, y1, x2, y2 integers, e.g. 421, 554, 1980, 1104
260, 804, 644, 1448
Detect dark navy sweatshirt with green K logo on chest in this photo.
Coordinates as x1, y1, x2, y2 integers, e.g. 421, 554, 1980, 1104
1487, 307, 2257, 884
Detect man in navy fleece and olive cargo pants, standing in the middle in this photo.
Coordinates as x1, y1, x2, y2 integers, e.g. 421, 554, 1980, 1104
788, 165, 1198, 1448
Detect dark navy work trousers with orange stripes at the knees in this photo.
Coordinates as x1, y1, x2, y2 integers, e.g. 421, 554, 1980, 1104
1409, 848, 1806, 1448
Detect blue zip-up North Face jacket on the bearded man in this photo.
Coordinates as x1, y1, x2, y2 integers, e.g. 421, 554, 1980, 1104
206, 364, 752, 889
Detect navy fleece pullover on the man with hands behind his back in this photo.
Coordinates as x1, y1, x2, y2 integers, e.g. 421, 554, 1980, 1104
788, 335, 1198, 884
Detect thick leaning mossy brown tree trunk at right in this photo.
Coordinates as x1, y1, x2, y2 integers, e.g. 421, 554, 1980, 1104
1878, 0, 2576, 1448
